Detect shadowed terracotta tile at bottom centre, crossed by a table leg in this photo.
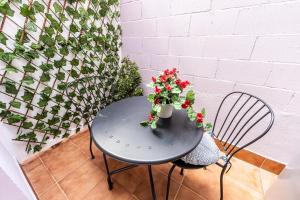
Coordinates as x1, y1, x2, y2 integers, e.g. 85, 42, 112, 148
133, 170, 180, 200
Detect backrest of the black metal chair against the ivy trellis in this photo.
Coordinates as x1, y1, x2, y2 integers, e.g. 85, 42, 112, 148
66, 76, 112, 125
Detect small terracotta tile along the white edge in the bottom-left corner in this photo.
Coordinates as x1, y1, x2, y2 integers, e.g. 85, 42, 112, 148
26, 163, 55, 195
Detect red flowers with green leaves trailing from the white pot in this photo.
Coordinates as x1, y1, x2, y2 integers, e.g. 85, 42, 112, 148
141, 68, 212, 130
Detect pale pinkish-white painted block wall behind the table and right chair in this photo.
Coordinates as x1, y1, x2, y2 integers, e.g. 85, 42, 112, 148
121, 0, 300, 163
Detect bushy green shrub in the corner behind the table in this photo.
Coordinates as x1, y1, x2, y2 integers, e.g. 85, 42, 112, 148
114, 58, 143, 100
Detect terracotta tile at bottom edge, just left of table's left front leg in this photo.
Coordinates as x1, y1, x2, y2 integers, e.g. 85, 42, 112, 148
59, 161, 106, 200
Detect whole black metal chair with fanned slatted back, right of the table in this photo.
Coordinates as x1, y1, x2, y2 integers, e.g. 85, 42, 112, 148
166, 92, 274, 200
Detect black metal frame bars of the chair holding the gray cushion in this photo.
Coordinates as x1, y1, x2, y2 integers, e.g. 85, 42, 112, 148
166, 91, 274, 200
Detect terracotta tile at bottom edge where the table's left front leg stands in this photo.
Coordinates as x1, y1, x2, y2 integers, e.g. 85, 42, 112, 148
83, 179, 132, 200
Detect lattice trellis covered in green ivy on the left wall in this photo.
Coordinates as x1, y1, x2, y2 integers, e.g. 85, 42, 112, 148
0, 0, 121, 152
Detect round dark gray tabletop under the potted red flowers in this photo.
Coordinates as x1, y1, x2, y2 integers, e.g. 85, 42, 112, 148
92, 97, 203, 164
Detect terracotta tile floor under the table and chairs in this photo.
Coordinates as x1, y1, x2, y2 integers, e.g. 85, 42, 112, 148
22, 132, 277, 200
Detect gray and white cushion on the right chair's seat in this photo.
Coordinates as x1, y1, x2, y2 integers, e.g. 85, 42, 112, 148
181, 133, 221, 165
